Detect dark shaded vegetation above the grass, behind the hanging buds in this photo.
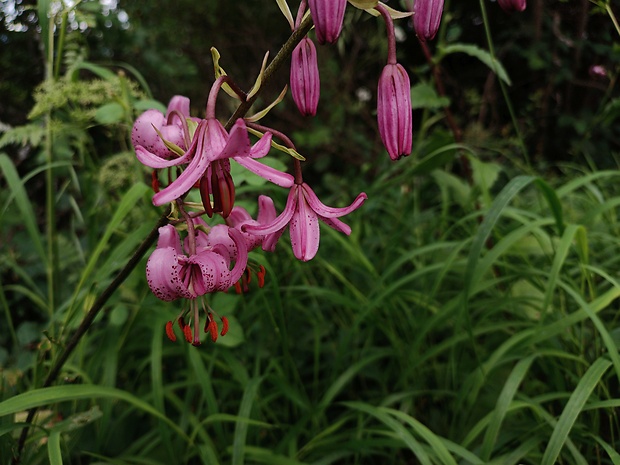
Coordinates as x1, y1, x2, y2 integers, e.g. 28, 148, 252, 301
0, 0, 620, 172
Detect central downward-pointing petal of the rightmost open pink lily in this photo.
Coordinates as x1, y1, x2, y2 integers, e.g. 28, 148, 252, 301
289, 189, 321, 262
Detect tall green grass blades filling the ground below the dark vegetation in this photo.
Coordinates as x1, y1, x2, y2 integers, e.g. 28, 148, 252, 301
0, 154, 620, 464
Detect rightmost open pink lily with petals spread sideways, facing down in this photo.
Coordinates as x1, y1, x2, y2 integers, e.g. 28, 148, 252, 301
241, 182, 368, 262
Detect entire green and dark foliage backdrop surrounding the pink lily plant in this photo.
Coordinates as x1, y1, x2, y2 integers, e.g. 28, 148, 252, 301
0, 0, 620, 465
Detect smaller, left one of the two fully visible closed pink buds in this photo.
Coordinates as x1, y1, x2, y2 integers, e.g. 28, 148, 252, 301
291, 37, 321, 116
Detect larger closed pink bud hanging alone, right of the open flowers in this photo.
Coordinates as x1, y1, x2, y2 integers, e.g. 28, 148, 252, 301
377, 63, 413, 160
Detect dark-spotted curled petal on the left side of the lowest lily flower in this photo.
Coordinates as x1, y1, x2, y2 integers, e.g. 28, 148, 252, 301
146, 246, 181, 302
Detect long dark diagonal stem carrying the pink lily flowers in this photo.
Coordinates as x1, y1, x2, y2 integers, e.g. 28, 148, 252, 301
11, 15, 312, 465
